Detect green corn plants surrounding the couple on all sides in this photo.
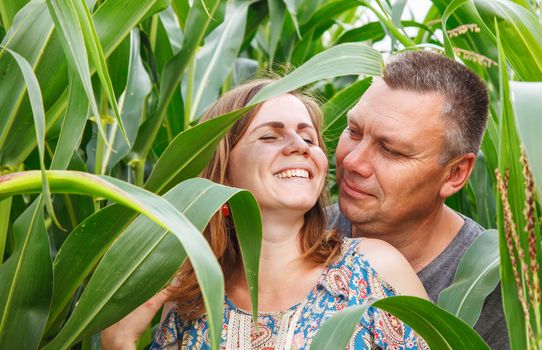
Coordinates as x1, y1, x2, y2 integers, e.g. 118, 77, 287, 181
0, 0, 542, 350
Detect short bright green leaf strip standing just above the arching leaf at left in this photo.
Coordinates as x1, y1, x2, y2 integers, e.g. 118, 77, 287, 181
51, 72, 88, 170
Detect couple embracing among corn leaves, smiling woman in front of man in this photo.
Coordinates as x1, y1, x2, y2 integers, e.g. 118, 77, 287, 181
101, 51, 508, 349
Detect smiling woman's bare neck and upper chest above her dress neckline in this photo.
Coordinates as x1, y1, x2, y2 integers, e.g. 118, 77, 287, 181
226, 212, 323, 311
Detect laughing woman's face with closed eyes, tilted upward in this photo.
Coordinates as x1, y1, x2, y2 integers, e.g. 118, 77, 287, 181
229, 94, 327, 213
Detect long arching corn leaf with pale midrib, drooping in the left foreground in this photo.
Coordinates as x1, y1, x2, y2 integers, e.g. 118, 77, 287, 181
0, 171, 224, 349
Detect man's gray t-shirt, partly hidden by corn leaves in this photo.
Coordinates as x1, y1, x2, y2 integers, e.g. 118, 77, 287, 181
327, 204, 510, 350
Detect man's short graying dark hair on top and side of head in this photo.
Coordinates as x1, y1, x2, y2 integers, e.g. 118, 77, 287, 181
383, 51, 489, 163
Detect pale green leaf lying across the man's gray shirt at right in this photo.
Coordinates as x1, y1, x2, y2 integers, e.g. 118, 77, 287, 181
438, 230, 500, 327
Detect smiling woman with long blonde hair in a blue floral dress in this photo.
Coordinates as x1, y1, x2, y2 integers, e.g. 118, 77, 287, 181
102, 80, 427, 349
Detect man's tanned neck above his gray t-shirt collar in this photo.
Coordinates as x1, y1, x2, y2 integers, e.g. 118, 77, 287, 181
352, 205, 465, 272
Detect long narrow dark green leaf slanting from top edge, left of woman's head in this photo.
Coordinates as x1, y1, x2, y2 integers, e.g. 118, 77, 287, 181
132, 0, 221, 159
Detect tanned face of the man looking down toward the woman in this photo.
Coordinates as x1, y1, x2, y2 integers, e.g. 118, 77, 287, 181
337, 80, 447, 234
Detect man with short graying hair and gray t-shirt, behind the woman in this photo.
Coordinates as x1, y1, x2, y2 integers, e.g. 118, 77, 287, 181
330, 51, 509, 349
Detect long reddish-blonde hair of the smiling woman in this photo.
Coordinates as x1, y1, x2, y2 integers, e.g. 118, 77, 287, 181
168, 79, 340, 320
